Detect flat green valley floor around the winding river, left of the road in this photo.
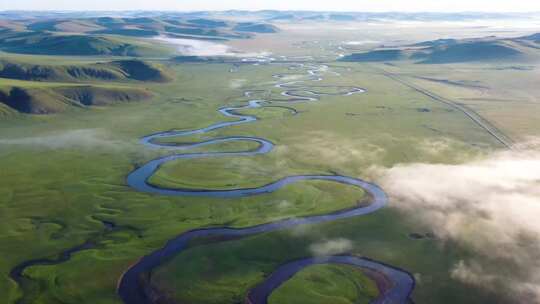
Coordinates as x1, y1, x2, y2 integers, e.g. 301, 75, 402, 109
0, 56, 506, 303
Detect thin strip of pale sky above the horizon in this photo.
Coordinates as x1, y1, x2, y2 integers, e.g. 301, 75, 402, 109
0, 0, 540, 12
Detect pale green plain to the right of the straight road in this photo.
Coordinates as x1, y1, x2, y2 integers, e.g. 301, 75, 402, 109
378, 61, 540, 142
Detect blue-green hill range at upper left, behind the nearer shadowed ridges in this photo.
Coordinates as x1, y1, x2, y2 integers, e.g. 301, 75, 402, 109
0, 13, 279, 57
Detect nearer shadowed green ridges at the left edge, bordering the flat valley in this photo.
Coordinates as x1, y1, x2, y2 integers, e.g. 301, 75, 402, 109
0, 59, 167, 116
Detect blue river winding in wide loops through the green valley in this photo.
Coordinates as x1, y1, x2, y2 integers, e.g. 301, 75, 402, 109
118, 65, 415, 304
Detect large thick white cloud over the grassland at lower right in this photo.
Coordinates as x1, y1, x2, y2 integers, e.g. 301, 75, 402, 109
376, 144, 540, 303
